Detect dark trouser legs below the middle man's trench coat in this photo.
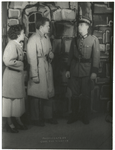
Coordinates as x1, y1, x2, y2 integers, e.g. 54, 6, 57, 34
29, 96, 53, 120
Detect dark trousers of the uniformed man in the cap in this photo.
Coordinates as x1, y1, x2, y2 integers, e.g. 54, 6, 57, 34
69, 77, 91, 117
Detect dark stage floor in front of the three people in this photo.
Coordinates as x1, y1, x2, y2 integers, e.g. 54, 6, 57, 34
2, 113, 112, 150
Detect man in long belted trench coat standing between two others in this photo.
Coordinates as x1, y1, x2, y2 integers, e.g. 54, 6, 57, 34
27, 17, 57, 126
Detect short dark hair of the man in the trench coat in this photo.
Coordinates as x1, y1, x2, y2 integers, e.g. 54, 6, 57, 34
36, 17, 49, 30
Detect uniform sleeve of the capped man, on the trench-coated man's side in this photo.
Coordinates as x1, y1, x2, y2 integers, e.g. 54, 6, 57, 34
66, 39, 74, 71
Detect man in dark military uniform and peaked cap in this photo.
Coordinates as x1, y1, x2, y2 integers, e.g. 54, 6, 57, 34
66, 17, 100, 124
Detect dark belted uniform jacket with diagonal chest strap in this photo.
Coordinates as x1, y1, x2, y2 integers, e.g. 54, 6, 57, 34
67, 35, 100, 77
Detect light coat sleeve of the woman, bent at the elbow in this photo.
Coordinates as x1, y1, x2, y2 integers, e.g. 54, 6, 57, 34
3, 43, 24, 71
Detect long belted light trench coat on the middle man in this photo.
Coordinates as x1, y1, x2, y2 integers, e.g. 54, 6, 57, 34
27, 30, 54, 99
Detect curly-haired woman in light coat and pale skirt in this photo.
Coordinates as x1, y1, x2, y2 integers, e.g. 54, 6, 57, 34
2, 25, 27, 133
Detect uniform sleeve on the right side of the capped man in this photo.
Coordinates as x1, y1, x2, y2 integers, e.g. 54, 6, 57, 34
92, 37, 100, 74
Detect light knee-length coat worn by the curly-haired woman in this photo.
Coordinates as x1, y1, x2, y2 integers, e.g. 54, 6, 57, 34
3, 40, 25, 99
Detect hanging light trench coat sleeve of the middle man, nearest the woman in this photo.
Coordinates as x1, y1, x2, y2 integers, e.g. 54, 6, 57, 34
27, 37, 38, 78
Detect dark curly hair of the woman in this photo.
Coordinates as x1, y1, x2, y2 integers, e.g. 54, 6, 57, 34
8, 24, 25, 40
